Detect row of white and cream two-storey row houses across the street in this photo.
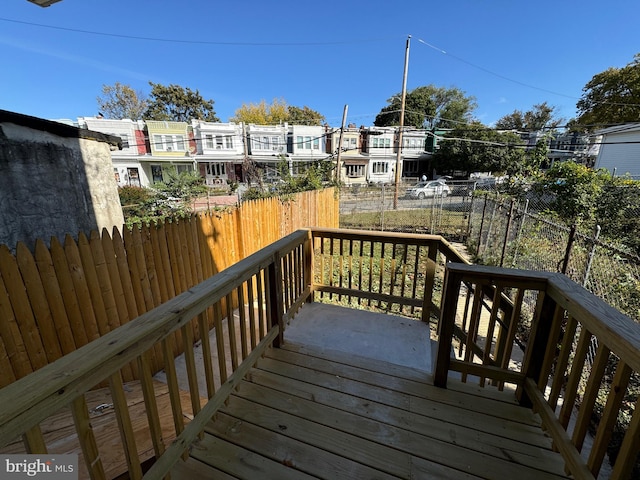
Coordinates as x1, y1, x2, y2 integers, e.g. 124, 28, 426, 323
77, 117, 430, 188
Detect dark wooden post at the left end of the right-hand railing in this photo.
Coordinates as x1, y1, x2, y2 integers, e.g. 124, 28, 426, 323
433, 269, 462, 388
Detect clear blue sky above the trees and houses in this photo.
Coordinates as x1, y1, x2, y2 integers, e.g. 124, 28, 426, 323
0, 0, 640, 126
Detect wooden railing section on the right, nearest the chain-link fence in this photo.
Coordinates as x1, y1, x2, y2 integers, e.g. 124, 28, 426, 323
434, 264, 640, 479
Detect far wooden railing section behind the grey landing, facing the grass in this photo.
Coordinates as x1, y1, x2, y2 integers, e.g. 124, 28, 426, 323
312, 228, 468, 321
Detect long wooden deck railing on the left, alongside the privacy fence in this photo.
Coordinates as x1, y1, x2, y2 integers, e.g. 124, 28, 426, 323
0, 230, 311, 479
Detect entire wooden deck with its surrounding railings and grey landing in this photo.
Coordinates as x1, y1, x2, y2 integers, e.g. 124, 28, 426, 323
0, 229, 640, 479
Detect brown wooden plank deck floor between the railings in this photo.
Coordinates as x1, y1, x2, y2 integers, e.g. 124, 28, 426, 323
171, 344, 567, 480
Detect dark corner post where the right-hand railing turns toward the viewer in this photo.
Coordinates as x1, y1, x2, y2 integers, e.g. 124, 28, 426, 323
516, 291, 556, 407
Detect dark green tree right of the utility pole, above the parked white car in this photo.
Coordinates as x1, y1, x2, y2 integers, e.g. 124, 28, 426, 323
434, 122, 525, 175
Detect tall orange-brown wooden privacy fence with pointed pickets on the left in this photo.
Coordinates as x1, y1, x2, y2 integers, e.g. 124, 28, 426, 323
0, 189, 338, 388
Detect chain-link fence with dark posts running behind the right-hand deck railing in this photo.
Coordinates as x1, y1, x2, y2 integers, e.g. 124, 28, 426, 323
467, 194, 640, 321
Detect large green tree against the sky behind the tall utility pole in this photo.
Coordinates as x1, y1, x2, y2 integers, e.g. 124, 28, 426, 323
373, 85, 477, 128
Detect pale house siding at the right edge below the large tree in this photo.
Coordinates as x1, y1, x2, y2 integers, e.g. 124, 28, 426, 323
595, 125, 640, 177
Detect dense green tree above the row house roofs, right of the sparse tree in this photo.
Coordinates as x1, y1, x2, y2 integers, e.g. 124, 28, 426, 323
143, 82, 220, 122
